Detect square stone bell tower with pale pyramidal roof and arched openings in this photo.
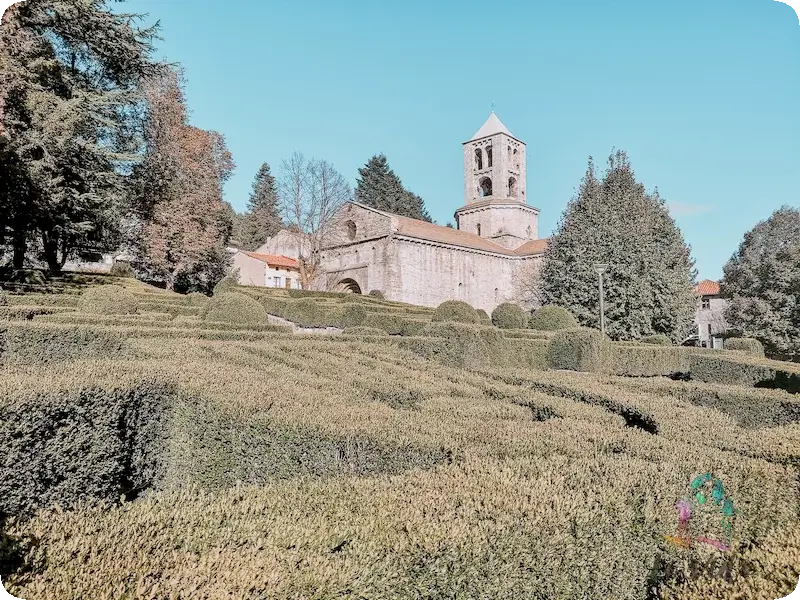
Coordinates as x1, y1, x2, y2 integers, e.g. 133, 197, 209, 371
455, 112, 539, 249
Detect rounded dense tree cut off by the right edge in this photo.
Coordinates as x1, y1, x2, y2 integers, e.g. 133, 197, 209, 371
720, 206, 800, 361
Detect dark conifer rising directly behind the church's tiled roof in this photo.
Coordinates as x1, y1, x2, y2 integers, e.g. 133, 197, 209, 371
355, 154, 431, 223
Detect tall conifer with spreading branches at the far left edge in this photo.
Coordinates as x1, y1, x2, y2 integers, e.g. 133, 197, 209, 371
0, 0, 155, 269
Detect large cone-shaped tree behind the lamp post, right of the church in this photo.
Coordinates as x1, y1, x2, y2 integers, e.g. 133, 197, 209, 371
541, 151, 696, 341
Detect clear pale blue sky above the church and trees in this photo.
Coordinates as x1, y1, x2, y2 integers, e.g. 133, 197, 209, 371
122, 0, 800, 279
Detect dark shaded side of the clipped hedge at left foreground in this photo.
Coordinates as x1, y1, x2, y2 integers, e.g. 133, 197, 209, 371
0, 379, 177, 516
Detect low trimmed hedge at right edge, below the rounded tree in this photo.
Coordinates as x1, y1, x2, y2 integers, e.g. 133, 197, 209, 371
689, 351, 800, 394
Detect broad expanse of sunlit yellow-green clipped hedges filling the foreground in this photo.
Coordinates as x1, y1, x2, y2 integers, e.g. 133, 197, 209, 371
0, 274, 800, 600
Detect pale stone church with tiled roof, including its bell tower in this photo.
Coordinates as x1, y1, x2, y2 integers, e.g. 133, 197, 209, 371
256, 112, 547, 312
